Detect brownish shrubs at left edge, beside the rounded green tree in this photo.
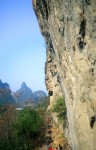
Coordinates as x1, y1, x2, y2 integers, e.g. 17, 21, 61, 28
0, 105, 16, 150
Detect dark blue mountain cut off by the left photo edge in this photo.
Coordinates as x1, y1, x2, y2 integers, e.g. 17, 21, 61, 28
0, 80, 15, 105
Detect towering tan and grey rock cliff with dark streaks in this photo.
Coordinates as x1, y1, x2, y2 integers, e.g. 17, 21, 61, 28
33, 0, 96, 150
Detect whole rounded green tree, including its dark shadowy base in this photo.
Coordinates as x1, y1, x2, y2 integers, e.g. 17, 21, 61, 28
15, 108, 43, 150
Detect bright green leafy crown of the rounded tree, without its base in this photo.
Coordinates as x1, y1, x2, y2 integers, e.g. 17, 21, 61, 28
16, 109, 43, 137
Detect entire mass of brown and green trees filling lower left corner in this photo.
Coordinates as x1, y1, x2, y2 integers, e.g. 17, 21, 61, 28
0, 106, 44, 150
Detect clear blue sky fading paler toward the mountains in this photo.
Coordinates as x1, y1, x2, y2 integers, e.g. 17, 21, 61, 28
0, 0, 46, 91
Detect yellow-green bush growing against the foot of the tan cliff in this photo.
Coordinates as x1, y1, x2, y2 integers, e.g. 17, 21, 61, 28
52, 97, 67, 121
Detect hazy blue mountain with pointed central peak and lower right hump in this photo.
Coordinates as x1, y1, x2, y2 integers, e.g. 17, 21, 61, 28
14, 82, 46, 105
